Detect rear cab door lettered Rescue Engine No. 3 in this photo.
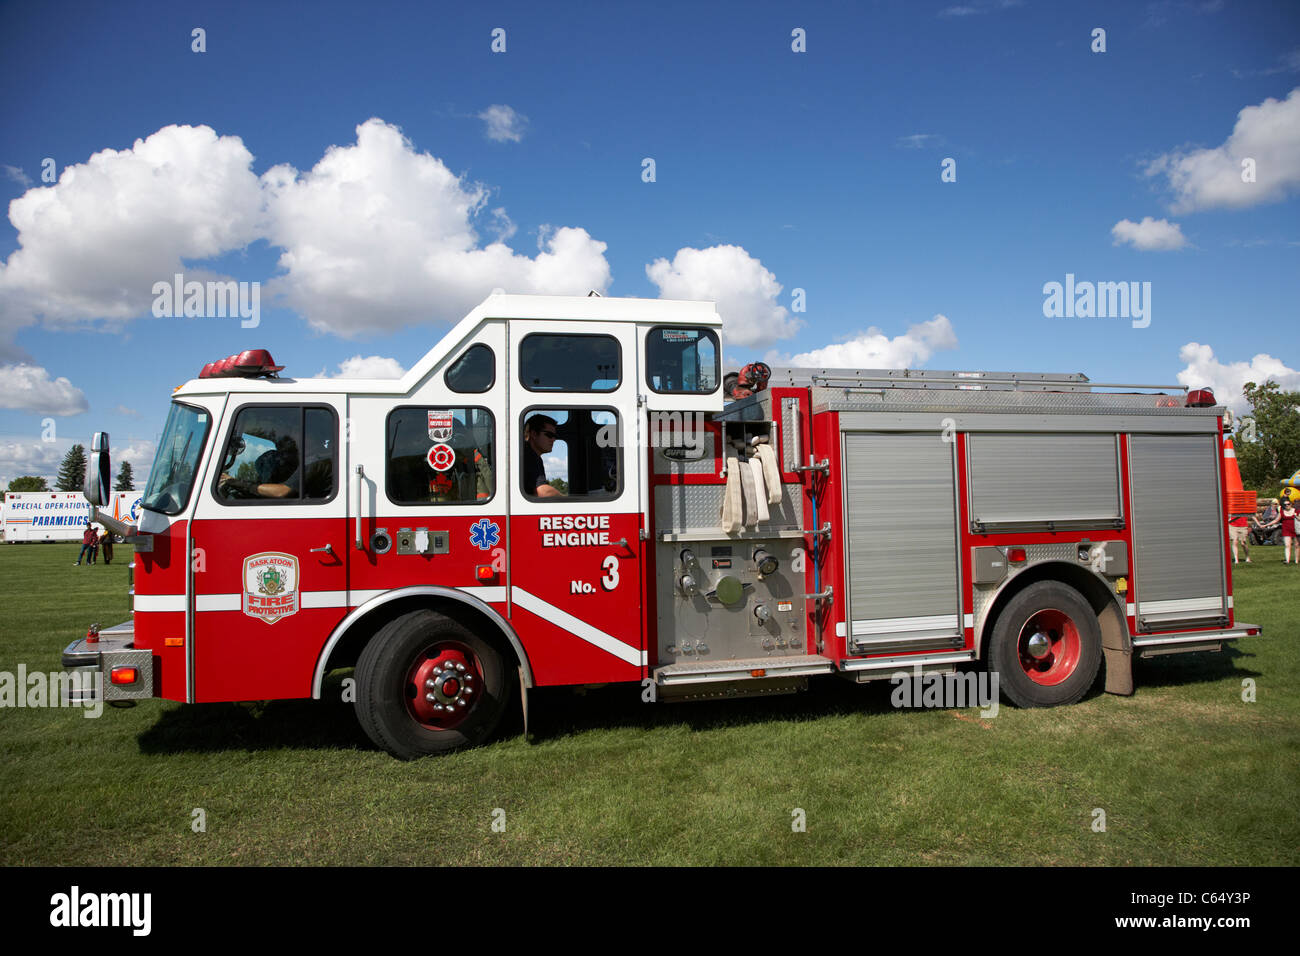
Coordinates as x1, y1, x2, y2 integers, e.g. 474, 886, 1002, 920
508, 320, 646, 684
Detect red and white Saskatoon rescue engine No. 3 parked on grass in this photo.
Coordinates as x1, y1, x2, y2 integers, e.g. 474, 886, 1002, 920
64, 295, 1258, 757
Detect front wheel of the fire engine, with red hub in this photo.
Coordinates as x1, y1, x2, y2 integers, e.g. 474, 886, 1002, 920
356, 610, 508, 760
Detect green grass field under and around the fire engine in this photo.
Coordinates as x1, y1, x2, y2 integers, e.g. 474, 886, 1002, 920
0, 545, 1300, 866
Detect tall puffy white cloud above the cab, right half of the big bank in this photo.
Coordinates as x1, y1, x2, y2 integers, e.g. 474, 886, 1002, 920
263, 120, 610, 337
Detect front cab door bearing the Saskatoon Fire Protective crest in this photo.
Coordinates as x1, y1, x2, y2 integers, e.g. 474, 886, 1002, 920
191, 397, 348, 702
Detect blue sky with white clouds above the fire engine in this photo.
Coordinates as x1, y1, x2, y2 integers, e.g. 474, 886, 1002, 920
0, 0, 1300, 483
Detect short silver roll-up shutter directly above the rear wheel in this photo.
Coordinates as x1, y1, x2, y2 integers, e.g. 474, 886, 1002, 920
967, 433, 1122, 525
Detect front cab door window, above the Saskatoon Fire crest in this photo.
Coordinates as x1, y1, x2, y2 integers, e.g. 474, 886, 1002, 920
215, 405, 338, 505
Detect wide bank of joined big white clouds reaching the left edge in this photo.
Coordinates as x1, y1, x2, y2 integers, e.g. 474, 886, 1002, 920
0, 118, 611, 345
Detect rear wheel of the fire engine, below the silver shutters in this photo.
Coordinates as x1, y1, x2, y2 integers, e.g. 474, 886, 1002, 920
988, 581, 1101, 708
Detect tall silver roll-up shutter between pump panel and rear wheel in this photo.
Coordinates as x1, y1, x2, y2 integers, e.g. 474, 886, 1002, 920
844, 432, 962, 653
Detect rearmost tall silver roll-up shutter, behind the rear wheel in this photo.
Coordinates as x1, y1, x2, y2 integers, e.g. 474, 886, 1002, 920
1128, 434, 1227, 631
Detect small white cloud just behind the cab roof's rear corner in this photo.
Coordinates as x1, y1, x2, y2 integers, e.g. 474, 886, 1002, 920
646, 246, 800, 346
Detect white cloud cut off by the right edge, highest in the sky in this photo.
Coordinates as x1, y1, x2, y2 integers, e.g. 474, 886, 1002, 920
1147, 87, 1300, 213
